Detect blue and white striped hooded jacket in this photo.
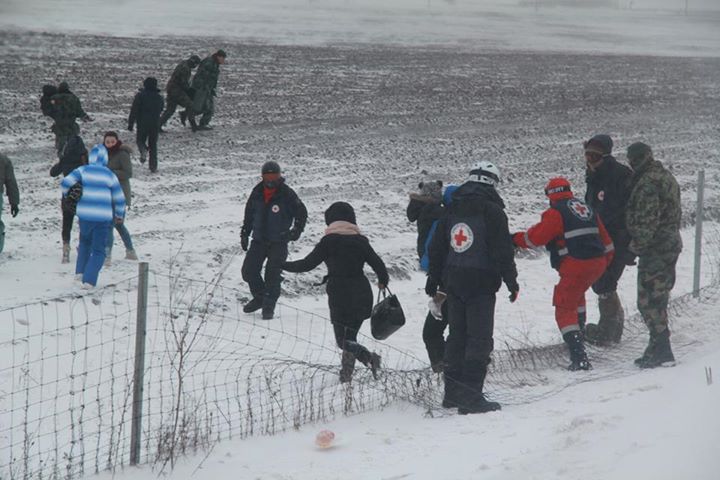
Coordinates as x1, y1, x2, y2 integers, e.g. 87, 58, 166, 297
62, 145, 125, 222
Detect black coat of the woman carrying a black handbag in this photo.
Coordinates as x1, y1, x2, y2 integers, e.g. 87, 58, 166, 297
283, 233, 390, 328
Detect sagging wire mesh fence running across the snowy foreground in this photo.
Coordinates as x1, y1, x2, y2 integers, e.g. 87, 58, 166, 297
0, 194, 720, 480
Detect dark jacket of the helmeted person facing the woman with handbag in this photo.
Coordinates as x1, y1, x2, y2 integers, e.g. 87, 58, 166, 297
241, 182, 307, 242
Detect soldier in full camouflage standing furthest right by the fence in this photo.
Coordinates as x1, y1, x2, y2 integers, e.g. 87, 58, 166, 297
626, 142, 682, 368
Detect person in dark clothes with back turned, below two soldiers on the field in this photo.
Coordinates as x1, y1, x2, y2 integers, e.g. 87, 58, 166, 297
128, 77, 165, 173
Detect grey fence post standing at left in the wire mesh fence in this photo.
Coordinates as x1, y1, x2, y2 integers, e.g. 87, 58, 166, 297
130, 262, 149, 465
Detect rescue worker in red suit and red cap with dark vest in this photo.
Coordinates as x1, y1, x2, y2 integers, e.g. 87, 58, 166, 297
513, 177, 615, 371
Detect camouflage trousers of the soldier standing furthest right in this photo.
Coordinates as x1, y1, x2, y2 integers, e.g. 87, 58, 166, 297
637, 252, 680, 333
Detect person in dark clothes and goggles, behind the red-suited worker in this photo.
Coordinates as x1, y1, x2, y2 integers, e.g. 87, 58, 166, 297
584, 135, 635, 345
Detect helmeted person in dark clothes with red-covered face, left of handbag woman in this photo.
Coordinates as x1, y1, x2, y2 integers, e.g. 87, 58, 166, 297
240, 161, 307, 320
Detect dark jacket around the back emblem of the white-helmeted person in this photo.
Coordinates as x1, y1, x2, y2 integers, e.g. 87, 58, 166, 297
428, 182, 517, 298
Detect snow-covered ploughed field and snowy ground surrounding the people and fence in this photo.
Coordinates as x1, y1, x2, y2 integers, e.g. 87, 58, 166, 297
0, 0, 720, 479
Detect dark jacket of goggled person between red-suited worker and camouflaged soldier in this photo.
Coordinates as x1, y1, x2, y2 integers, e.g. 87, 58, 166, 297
585, 155, 633, 249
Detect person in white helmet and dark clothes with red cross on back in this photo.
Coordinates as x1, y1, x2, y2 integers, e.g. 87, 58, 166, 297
425, 162, 520, 414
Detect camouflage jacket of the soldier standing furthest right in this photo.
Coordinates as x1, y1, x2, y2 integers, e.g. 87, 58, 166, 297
626, 160, 682, 256
